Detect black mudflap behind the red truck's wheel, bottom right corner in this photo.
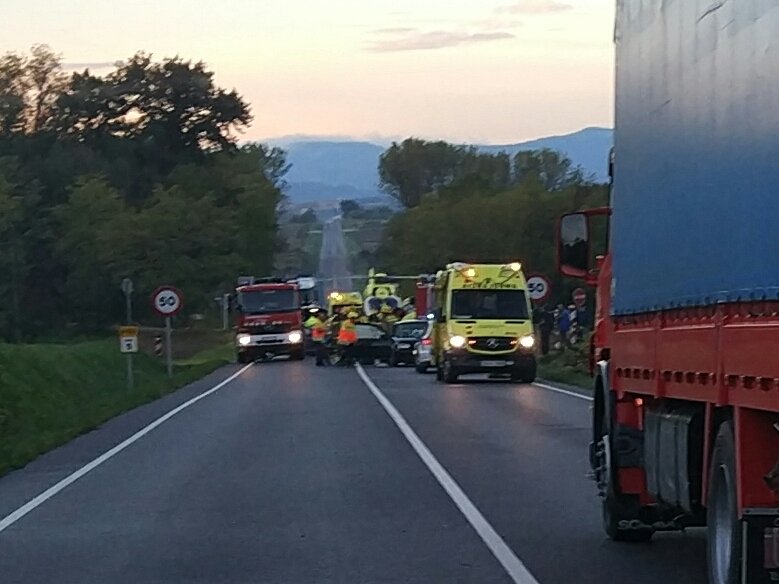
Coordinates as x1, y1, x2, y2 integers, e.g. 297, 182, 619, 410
741, 509, 779, 584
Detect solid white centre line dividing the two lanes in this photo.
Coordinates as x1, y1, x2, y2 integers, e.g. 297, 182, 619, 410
357, 364, 540, 584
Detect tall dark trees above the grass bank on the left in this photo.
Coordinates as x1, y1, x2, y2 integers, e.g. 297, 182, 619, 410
0, 46, 288, 340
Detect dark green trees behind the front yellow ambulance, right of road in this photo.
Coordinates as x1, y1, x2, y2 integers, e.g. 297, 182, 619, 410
377, 138, 608, 303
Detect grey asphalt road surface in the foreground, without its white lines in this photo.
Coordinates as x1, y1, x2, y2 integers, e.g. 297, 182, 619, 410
0, 360, 705, 584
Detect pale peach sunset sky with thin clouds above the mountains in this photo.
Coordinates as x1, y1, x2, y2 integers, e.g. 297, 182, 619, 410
0, 0, 615, 144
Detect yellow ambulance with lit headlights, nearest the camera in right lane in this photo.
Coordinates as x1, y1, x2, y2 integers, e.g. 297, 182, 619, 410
431, 262, 536, 383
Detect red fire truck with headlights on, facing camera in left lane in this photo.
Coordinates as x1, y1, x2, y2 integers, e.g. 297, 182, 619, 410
234, 276, 306, 363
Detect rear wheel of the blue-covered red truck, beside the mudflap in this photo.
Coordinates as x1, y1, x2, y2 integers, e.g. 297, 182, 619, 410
706, 422, 743, 584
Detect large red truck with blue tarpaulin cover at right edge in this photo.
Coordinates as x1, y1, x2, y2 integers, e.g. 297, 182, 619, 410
557, 0, 779, 584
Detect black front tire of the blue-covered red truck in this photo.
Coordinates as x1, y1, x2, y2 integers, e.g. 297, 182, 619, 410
594, 388, 654, 543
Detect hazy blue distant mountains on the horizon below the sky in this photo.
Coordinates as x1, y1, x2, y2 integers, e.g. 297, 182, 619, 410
269, 128, 613, 203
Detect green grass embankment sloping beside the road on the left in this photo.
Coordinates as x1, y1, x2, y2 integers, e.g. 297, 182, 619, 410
0, 338, 233, 475
